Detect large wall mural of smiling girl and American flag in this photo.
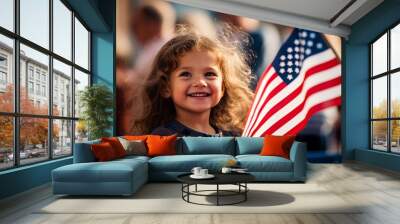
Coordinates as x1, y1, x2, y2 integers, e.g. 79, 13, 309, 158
116, 0, 341, 161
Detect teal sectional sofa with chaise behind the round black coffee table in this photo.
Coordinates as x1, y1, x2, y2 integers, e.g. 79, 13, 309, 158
52, 137, 307, 195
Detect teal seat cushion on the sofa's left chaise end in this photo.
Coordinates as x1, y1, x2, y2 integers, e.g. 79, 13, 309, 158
52, 159, 147, 182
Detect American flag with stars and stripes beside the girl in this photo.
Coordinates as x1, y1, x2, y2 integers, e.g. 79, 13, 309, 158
243, 28, 341, 137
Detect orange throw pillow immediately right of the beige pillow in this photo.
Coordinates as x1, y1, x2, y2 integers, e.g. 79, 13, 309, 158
146, 135, 176, 156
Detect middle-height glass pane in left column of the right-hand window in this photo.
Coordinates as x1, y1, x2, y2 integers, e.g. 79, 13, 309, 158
372, 76, 387, 118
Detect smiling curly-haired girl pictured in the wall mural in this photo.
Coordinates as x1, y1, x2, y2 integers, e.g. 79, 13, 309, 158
133, 27, 253, 136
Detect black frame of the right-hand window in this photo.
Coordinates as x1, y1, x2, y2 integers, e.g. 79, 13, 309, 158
368, 21, 400, 155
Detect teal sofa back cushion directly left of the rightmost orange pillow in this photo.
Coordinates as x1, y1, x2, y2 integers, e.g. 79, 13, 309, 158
236, 137, 264, 155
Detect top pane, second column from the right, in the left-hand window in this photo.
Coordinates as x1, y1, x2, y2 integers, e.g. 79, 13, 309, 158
53, 0, 72, 60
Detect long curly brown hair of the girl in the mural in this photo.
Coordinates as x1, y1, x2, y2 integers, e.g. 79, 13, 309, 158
132, 25, 253, 134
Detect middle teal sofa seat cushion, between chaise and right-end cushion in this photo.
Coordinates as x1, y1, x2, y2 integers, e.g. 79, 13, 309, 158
149, 154, 235, 172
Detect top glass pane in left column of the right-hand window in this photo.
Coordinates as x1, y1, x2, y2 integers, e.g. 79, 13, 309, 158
372, 34, 387, 75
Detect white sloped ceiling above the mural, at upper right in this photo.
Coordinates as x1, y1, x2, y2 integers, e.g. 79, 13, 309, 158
169, 0, 383, 37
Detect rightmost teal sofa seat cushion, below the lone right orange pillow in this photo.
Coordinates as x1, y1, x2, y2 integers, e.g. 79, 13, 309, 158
236, 155, 293, 172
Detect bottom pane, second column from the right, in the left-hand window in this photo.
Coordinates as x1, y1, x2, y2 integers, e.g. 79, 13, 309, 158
53, 120, 72, 158
